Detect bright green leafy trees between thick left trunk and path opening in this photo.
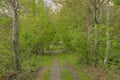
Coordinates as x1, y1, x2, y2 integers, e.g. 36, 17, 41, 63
20, 0, 55, 55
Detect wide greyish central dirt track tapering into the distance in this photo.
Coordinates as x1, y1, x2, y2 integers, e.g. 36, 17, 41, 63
50, 57, 61, 80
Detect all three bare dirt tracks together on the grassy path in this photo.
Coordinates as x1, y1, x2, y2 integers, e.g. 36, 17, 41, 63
36, 56, 80, 80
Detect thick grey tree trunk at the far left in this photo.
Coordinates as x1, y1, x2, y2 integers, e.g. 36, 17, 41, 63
12, 0, 20, 70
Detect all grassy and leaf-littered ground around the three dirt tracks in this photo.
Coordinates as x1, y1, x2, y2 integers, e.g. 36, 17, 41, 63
1, 54, 120, 80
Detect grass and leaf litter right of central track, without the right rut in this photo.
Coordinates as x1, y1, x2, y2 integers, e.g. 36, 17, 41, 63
58, 53, 120, 80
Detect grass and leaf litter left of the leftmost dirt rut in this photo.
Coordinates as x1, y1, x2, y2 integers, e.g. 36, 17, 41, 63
1, 55, 54, 80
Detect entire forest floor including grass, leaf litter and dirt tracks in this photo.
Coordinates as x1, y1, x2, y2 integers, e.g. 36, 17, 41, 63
2, 54, 120, 80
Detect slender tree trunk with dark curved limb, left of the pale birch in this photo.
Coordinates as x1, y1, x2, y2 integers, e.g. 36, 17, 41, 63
91, 0, 105, 66
